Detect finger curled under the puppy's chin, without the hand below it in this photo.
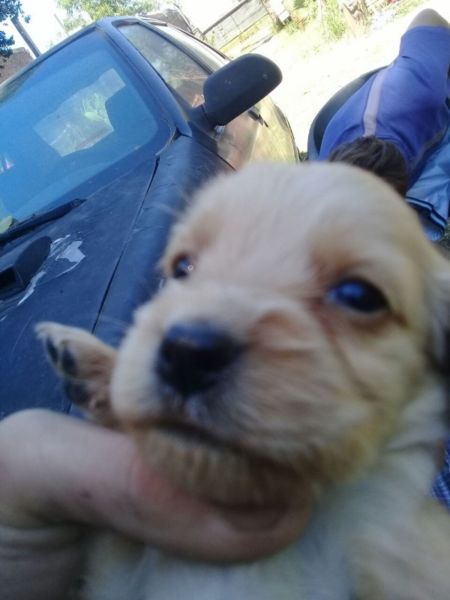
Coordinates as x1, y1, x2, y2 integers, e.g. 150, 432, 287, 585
0, 411, 309, 561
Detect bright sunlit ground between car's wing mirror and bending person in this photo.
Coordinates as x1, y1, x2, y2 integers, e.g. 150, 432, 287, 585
255, 0, 450, 151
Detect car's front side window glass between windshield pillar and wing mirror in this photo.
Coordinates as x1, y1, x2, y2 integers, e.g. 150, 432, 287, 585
120, 24, 209, 107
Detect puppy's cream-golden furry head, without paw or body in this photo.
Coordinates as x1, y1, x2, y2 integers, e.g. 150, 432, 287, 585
111, 164, 448, 504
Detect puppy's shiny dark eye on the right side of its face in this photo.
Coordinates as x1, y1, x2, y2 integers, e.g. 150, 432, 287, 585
327, 279, 388, 314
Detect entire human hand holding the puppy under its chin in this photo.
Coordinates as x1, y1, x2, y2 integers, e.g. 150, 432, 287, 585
0, 410, 309, 600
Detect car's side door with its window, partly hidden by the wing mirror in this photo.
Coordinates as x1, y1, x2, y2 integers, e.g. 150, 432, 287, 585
120, 21, 297, 168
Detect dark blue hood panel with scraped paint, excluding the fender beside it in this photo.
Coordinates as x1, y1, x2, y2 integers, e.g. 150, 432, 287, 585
0, 158, 156, 417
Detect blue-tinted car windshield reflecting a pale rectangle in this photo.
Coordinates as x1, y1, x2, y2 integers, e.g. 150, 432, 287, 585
0, 32, 169, 232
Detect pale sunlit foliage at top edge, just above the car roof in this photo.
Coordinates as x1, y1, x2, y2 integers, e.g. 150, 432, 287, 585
58, 0, 158, 24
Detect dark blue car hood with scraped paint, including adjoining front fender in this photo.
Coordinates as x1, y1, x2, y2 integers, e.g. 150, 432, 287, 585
0, 136, 230, 417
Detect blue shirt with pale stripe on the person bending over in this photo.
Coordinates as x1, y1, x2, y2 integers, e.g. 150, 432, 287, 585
319, 25, 450, 180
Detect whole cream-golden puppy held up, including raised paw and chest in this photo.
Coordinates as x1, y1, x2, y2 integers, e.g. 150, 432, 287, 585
39, 164, 450, 600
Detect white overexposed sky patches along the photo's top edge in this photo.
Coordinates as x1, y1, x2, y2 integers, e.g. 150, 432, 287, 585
5, 0, 237, 52
